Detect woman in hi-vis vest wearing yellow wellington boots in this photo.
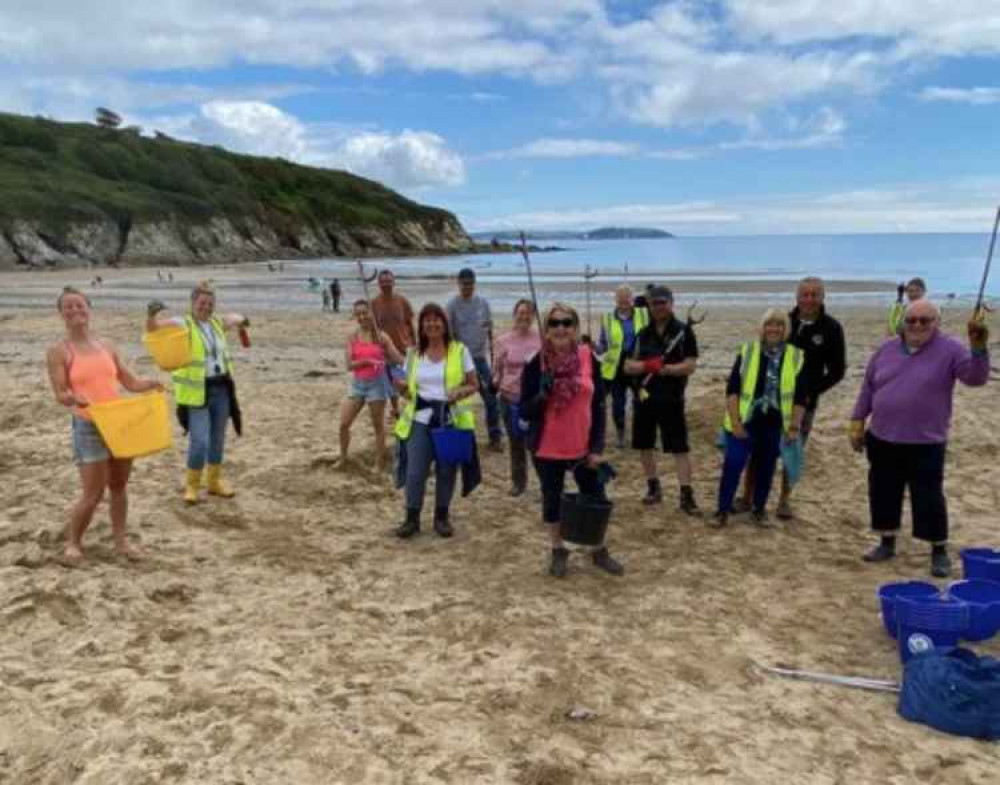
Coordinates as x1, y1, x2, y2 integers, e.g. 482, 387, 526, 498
146, 282, 250, 504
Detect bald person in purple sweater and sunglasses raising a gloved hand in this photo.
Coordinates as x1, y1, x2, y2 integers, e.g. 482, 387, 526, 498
850, 299, 990, 578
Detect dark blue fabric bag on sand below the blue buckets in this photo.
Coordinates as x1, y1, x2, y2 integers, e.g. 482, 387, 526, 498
898, 649, 1000, 741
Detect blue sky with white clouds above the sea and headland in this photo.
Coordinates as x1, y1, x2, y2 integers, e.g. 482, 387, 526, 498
0, 0, 1000, 235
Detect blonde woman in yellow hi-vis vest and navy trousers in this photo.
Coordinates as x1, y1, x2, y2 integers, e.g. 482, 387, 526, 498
714, 308, 808, 527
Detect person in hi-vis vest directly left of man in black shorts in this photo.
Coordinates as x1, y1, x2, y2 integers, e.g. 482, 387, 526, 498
597, 284, 652, 449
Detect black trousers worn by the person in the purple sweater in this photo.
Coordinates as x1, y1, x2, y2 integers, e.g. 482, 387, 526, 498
865, 432, 948, 543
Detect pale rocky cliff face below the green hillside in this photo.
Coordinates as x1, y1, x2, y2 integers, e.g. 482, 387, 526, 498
0, 217, 474, 269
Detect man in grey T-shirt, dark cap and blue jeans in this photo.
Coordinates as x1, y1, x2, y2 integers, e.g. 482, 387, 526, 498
447, 267, 503, 452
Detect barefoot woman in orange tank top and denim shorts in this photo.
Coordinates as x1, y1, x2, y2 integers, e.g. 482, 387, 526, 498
46, 286, 163, 566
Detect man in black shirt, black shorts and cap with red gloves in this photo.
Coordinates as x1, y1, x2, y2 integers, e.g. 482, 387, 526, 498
625, 286, 698, 515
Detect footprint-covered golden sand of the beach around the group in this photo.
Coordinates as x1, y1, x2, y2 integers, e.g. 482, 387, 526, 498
0, 266, 1000, 785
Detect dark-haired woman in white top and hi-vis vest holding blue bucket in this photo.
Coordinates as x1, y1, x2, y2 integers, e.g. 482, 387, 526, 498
396, 303, 479, 539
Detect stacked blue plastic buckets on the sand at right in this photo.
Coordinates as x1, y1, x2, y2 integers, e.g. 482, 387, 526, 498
878, 548, 1000, 665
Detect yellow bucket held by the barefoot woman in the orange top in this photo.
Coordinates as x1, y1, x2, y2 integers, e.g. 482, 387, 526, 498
87, 392, 174, 458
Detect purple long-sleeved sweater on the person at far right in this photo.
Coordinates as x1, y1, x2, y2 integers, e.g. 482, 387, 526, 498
853, 332, 990, 444
